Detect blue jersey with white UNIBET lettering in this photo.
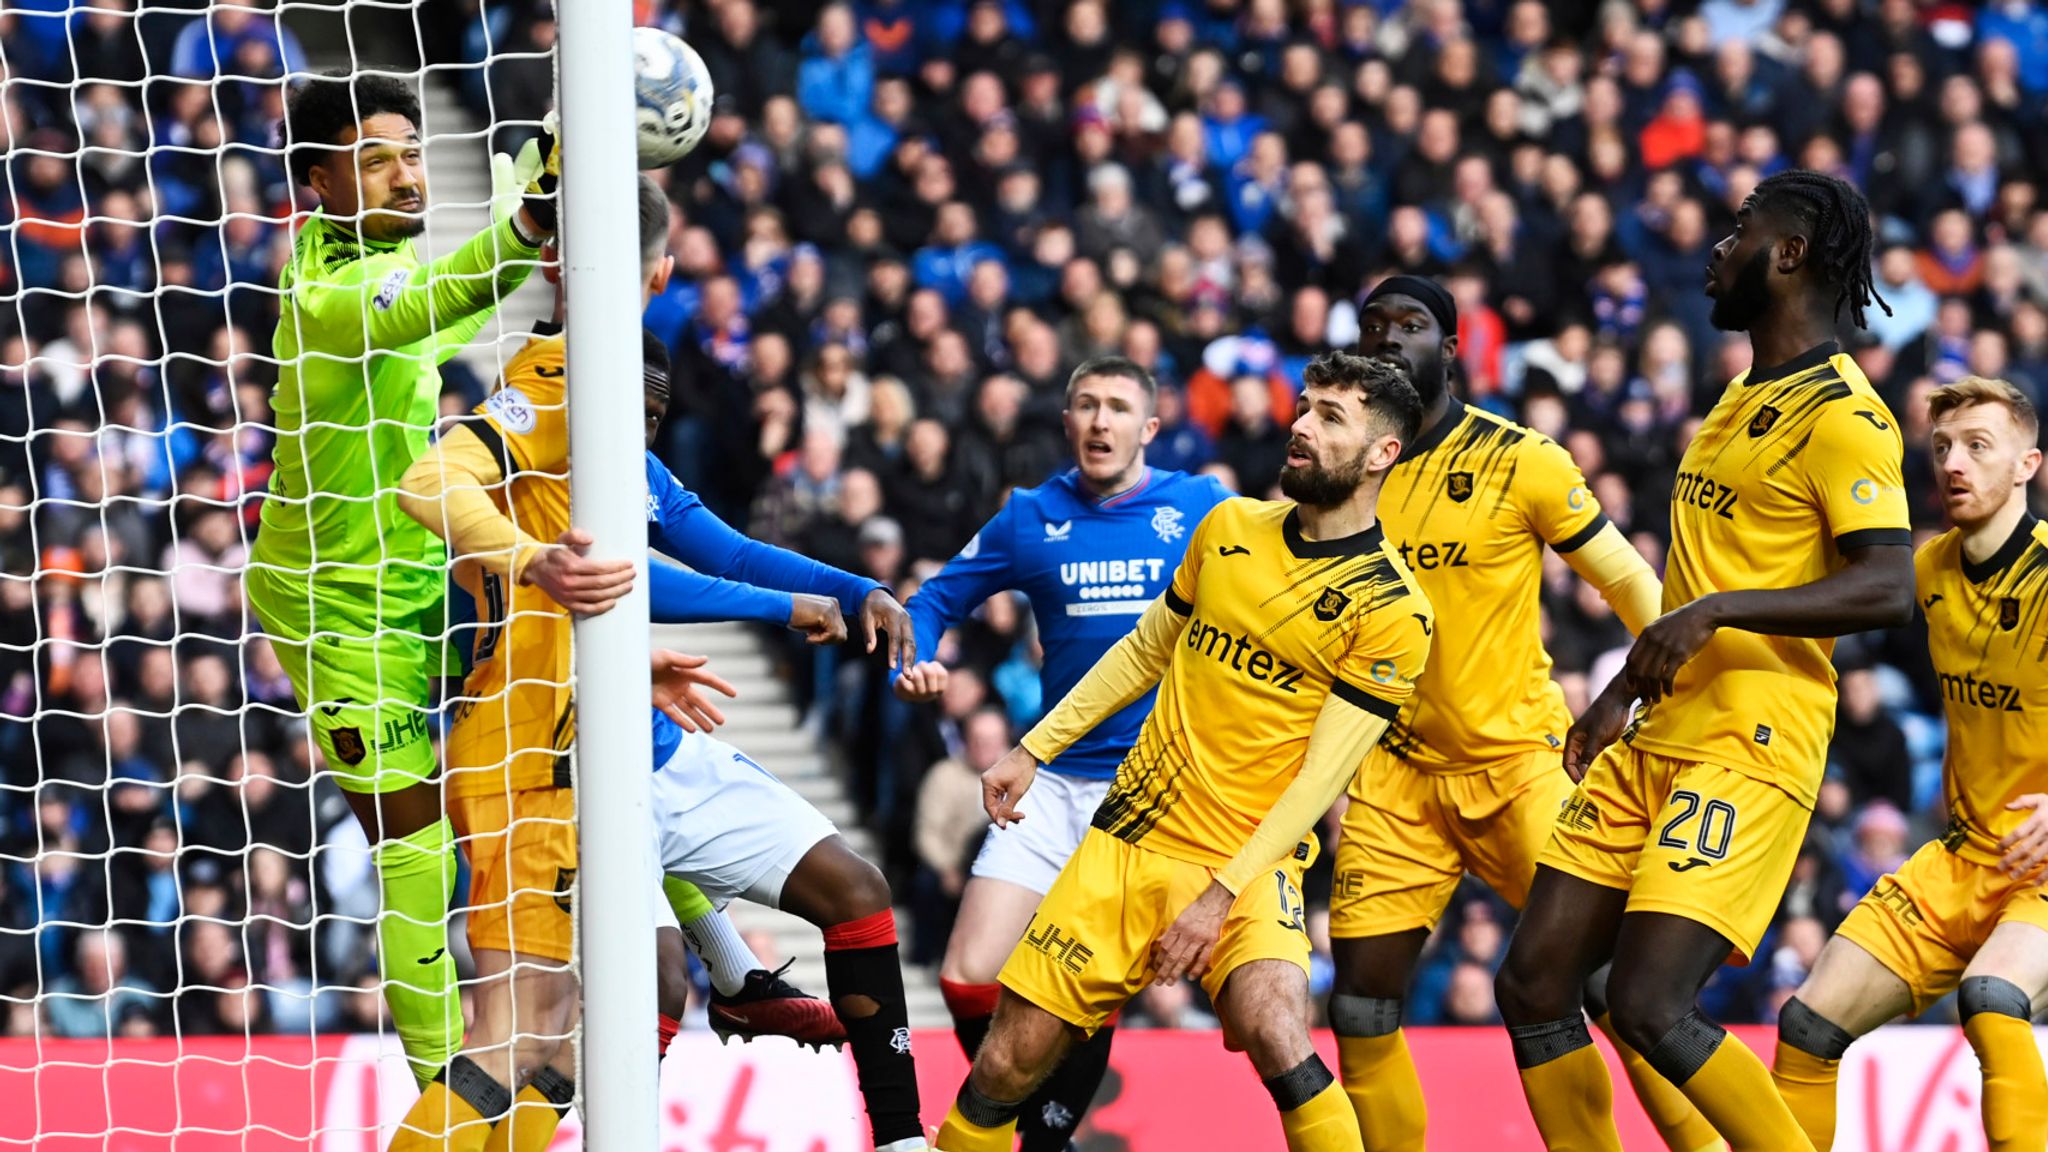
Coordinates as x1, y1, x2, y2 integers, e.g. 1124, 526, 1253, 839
905, 469, 1231, 779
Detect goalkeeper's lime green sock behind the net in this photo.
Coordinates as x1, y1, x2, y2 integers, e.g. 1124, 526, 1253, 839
375, 820, 463, 1088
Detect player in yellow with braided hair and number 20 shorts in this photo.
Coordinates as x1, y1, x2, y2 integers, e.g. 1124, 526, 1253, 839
1495, 170, 1913, 1152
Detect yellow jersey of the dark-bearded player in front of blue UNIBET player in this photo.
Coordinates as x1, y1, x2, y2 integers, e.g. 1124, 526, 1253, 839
1094, 498, 1436, 867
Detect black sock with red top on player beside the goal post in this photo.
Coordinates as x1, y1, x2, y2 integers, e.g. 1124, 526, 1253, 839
825, 912, 924, 1146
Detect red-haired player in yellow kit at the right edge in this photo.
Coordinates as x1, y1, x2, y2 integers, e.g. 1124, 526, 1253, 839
1774, 377, 2048, 1152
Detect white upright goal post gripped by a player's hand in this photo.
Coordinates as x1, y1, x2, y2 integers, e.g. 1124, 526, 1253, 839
559, 0, 659, 1152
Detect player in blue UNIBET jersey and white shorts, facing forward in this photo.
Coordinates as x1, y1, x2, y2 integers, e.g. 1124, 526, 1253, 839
895, 357, 1231, 1152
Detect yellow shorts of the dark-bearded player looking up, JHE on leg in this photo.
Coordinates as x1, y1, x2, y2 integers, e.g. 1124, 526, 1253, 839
997, 828, 1317, 1035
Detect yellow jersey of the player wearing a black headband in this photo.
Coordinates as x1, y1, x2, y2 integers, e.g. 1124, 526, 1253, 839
1380, 400, 1608, 771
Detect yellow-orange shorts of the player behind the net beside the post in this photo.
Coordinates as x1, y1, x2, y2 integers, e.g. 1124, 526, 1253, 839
449, 787, 575, 961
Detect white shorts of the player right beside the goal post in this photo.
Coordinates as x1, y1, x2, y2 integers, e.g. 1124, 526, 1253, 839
653, 732, 838, 908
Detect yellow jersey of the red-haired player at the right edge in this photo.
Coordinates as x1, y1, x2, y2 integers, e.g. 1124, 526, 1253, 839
1913, 517, 2048, 865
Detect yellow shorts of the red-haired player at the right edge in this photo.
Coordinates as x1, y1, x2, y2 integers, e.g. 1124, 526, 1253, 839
1837, 842, 2048, 1017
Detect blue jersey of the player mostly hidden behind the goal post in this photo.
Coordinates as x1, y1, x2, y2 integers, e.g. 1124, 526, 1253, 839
647, 453, 881, 769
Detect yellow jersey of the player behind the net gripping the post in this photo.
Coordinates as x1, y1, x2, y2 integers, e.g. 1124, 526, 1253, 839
444, 336, 575, 795
